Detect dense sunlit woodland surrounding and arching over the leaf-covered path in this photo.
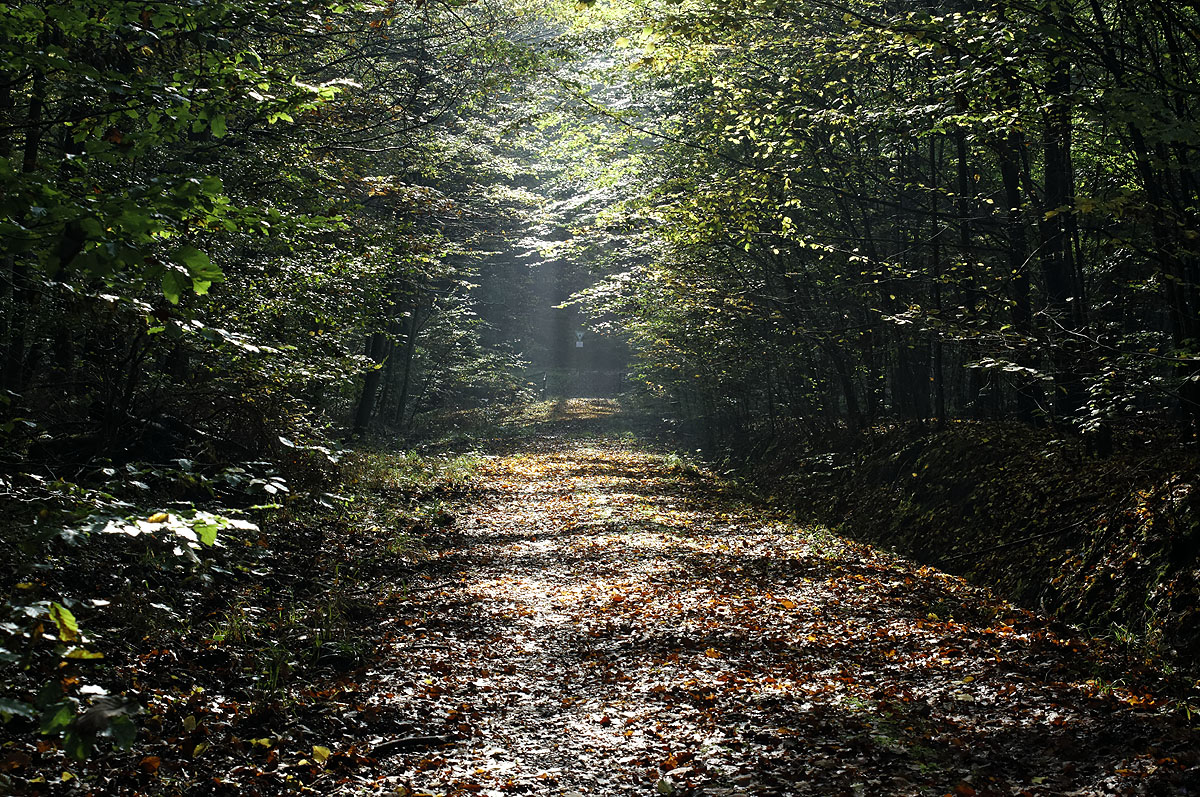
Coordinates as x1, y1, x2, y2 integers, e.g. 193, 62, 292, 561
0, 0, 1200, 793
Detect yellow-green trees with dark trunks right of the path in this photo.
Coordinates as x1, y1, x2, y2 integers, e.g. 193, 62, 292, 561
566, 0, 1200, 441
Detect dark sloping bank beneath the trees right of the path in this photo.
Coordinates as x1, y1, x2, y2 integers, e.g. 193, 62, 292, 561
732, 421, 1200, 669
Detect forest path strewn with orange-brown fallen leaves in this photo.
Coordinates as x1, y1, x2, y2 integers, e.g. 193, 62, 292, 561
370, 408, 1196, 796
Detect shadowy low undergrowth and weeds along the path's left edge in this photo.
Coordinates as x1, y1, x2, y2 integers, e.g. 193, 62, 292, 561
0, 451, 481, 793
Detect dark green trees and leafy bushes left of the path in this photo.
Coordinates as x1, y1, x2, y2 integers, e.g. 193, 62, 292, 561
0, 0, 566, 772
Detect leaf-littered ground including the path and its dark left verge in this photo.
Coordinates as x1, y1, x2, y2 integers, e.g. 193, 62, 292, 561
0, 401, 1200, 797
